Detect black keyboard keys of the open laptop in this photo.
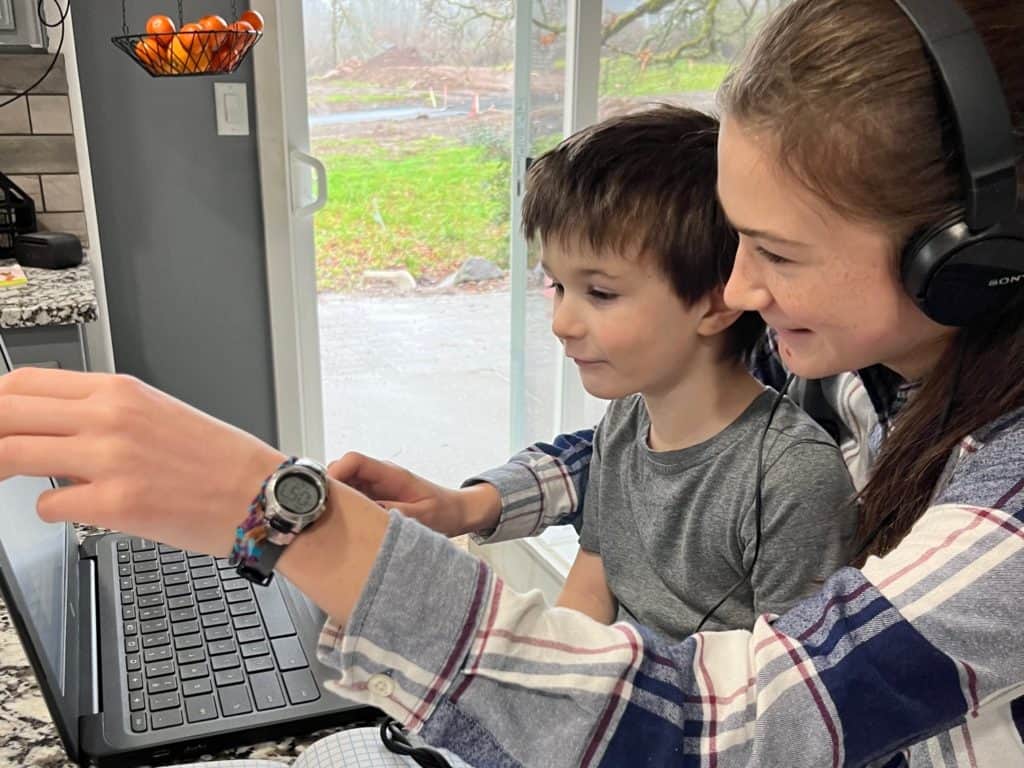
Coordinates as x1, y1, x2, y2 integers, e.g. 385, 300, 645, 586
117, 538, 321, 733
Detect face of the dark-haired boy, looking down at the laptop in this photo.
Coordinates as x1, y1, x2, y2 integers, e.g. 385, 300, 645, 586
543, 238, 711, 399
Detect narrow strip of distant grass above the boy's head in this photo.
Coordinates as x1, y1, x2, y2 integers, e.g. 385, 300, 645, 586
600, 57, 729, 97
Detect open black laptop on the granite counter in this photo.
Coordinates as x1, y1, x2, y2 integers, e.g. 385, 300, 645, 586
0, 340, 381, 766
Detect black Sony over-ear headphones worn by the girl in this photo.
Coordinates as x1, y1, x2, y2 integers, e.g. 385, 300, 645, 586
894, 0, 1024, 326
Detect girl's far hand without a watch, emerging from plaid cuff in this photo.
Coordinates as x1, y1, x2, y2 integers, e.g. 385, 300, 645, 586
328, 452, 501, 536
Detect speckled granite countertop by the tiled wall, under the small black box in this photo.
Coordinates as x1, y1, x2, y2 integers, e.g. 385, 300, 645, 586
0, 258, 98, 328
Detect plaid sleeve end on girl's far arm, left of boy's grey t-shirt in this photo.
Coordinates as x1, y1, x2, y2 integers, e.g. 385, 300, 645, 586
463, 429, 594, 544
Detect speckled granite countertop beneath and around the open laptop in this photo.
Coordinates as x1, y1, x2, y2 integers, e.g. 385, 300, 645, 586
0, 528, 356, 768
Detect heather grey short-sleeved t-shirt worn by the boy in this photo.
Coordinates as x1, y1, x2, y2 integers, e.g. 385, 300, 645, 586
580, 390, 857, 638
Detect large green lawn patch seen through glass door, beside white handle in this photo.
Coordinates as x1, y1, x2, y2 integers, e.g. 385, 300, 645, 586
316, 139, 509, 291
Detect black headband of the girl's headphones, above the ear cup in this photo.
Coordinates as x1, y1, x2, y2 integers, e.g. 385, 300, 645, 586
894, 0, 1018, 231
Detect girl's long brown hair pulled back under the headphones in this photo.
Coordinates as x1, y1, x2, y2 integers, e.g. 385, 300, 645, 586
721, 0, 1024, 555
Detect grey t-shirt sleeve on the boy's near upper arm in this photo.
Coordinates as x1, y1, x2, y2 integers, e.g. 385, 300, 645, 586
740, 435, 858, 613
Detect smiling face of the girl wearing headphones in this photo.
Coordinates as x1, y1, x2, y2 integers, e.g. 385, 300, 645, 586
718, 118, 955, 380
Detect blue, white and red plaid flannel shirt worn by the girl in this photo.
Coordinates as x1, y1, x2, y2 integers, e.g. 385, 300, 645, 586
319, 333, 1024, 768
